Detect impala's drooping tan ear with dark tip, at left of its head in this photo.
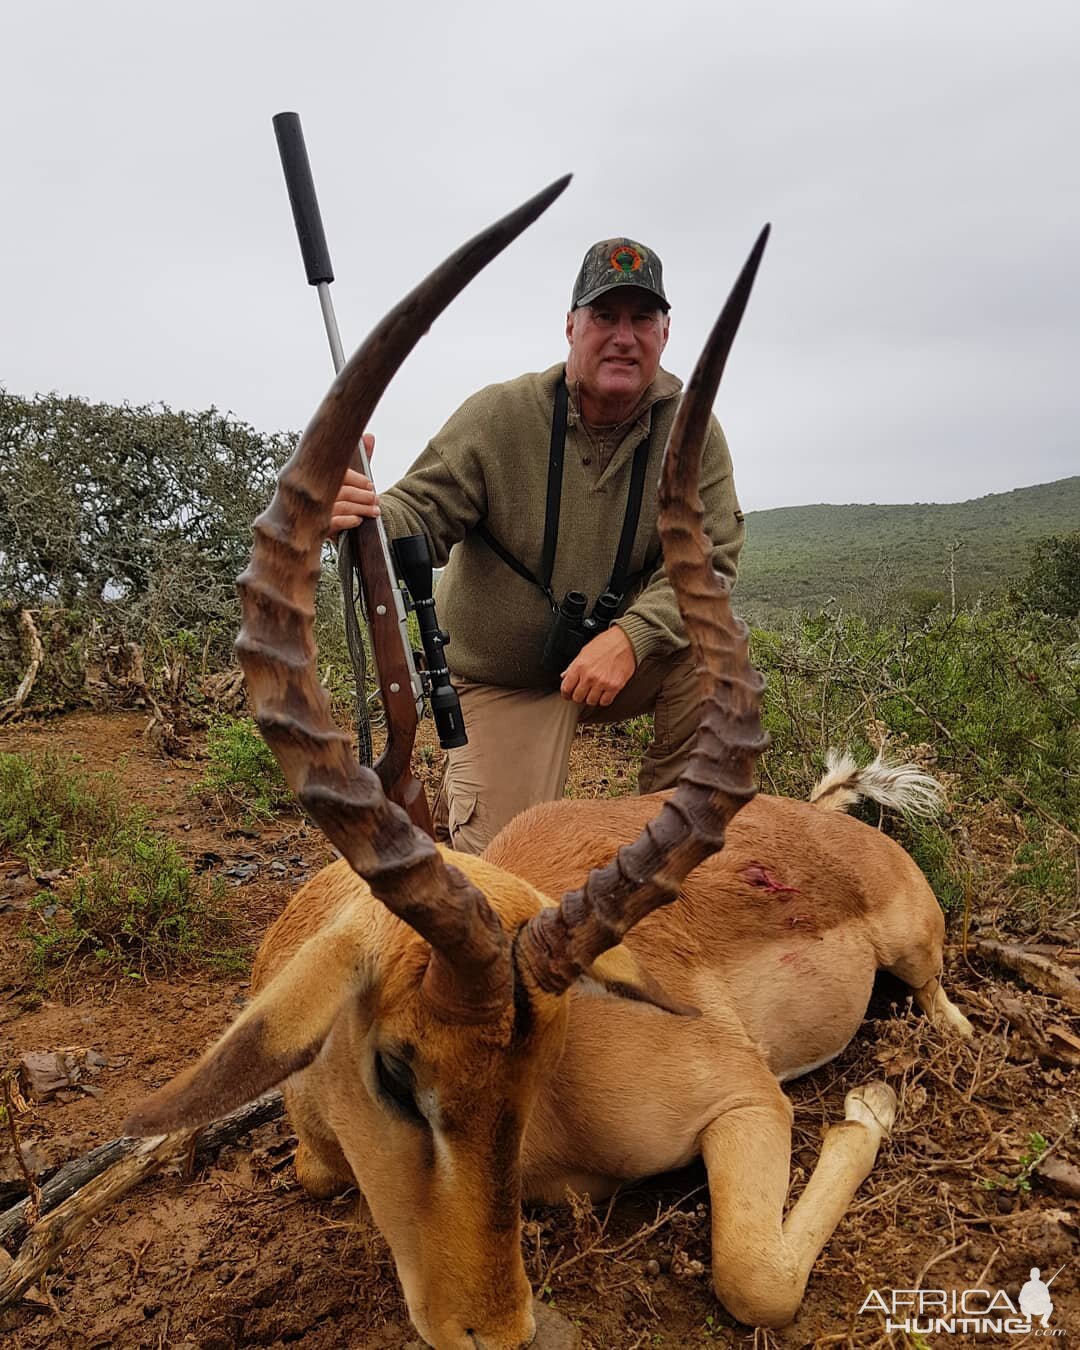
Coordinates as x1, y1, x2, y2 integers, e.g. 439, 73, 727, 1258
124, 911, 375, 1138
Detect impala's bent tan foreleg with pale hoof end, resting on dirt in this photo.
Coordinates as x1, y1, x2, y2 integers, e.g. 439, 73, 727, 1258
702, 1080, 896, 1327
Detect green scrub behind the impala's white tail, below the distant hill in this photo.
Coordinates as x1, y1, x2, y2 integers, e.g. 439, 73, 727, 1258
752, 606, 1080, 907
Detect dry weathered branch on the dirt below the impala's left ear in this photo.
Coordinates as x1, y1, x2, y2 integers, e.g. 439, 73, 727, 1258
0, 1092, 285, 1269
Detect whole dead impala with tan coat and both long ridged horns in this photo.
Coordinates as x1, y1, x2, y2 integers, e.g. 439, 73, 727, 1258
128, 197, 967, 1350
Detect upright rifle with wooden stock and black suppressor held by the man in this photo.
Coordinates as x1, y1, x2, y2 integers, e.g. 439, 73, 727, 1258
273, 112, 437, 836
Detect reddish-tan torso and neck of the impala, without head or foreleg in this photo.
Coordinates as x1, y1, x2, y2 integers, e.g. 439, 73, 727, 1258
486, 797, 945, 1200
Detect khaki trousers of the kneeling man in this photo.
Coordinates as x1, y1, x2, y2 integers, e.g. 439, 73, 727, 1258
435, 648, 701, 853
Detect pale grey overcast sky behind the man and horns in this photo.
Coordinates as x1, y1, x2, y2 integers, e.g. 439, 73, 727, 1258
0, 0, 1080, 510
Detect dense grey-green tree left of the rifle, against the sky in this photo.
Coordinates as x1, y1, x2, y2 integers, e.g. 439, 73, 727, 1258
0, 389, 294, 650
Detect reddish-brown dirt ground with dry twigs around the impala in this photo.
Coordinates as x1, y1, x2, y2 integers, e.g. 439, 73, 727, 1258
0, 713, 1080, 1350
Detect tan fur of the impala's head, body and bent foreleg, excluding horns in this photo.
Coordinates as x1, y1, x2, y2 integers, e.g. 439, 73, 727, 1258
130, 797, 967, 1350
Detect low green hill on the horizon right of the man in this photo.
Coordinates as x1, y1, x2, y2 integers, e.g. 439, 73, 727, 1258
737, 477, 1080, 621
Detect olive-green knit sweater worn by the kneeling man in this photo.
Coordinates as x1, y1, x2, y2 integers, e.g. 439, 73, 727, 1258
379, 365, 744, 689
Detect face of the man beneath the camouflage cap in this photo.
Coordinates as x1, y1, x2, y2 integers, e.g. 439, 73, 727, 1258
566, 286, 668, 416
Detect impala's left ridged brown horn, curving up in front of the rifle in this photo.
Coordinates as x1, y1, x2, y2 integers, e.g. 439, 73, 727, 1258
236, 176, 570, 1022
